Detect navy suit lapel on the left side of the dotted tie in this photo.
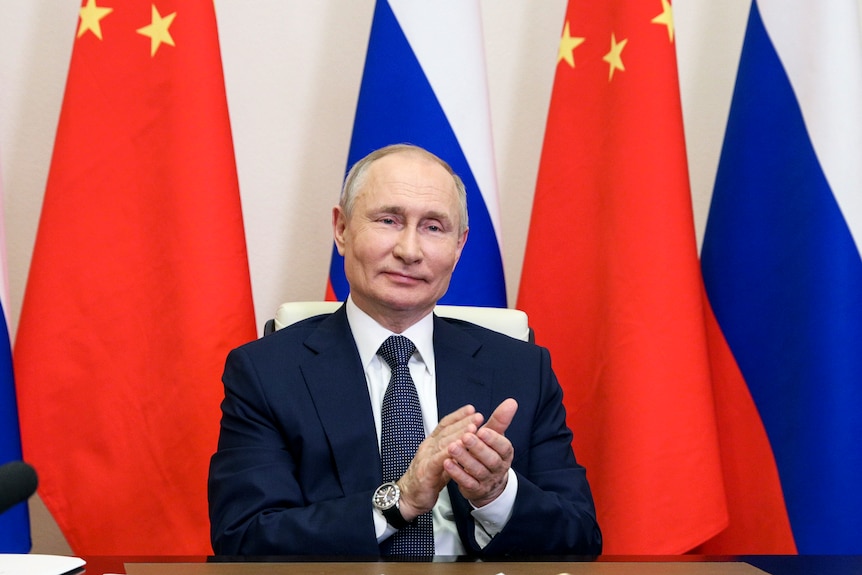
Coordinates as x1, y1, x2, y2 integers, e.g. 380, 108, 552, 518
302, 306, 382, 492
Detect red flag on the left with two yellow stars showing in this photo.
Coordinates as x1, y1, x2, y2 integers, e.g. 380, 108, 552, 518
14, 0, 256, 555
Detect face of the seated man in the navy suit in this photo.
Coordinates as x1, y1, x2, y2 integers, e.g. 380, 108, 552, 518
333, 152, 467, 332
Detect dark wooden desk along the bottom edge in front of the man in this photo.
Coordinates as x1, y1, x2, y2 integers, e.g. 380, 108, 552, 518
77, 555, 862, 575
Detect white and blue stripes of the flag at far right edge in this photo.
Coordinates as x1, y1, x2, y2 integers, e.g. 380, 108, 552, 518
701, 0, 862, 554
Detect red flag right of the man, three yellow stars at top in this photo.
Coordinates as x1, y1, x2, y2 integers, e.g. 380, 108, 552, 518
518, 0, 728, 554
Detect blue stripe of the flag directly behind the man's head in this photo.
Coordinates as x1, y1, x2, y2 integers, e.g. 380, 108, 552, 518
330, 0, 506, 307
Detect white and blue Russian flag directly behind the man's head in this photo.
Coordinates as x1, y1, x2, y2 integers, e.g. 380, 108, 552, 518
327, 0, 506, 307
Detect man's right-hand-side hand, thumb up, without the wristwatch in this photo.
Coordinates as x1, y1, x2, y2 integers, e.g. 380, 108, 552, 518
443, 398, 518, 507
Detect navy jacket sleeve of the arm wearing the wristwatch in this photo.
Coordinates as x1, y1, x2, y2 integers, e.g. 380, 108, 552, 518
208, 346, 379, 556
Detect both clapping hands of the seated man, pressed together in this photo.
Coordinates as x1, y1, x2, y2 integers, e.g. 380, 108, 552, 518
397, 398, 518, 521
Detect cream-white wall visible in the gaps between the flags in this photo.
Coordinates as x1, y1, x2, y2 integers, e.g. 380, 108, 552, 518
0, 0, 862, 553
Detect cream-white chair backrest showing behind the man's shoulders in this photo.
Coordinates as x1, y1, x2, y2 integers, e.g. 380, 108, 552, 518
263, 301, 533, 341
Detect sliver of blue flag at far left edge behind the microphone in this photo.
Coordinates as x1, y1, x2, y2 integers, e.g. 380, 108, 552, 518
0, 172, 31, 553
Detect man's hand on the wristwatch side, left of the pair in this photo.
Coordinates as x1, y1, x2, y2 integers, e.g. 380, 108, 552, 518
397, 405, 483, 521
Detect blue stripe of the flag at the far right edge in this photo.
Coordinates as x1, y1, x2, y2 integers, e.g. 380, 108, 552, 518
702, 2, 862, 554
